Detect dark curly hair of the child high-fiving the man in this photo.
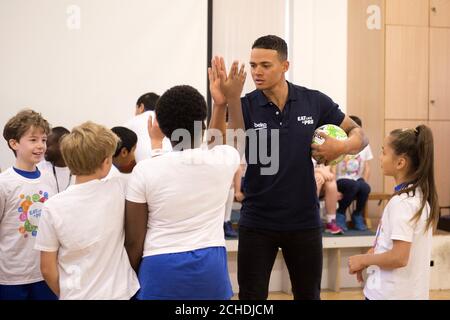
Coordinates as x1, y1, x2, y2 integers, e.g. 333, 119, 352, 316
155, 85, 206, 145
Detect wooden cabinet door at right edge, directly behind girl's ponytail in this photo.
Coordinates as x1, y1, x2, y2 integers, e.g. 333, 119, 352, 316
430, 121, 450, 206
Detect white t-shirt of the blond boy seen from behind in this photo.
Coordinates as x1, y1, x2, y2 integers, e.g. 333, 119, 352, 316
35, 177, 139, 300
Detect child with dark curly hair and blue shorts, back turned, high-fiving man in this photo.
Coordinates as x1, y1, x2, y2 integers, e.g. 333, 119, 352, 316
125, 86, 239, 300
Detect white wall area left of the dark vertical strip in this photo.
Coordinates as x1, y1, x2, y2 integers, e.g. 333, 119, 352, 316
0, 0, 207, 168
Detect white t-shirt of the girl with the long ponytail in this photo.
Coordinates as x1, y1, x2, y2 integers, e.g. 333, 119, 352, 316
364, 189, 433, 300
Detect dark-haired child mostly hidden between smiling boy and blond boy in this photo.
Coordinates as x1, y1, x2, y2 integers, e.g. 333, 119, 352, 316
38, 127, 75, 193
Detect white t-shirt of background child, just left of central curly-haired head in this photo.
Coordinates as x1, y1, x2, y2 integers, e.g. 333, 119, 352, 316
124, 111, 172, 163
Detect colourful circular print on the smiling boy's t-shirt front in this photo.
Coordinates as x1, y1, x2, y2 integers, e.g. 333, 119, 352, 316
17, 191, 48, 238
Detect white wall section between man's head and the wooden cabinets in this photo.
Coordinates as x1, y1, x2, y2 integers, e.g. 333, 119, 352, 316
290, 0, 347, 111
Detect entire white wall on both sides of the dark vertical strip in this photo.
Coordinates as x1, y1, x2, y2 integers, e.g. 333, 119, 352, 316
0, 0, 347, 168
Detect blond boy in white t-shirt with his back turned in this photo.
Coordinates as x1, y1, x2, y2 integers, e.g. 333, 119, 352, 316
35, 122, 139, 300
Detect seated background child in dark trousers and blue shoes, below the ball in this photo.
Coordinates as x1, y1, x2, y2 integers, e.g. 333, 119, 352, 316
332, 116, 373, 231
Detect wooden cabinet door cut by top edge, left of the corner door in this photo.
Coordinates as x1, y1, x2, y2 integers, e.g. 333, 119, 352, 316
386, 0, 429, 26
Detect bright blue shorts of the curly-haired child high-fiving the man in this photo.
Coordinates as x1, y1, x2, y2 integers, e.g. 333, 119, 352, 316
136, 247, 233, 300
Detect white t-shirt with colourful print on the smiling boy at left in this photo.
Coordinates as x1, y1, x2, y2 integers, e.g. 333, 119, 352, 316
0, 168, 56, 285
